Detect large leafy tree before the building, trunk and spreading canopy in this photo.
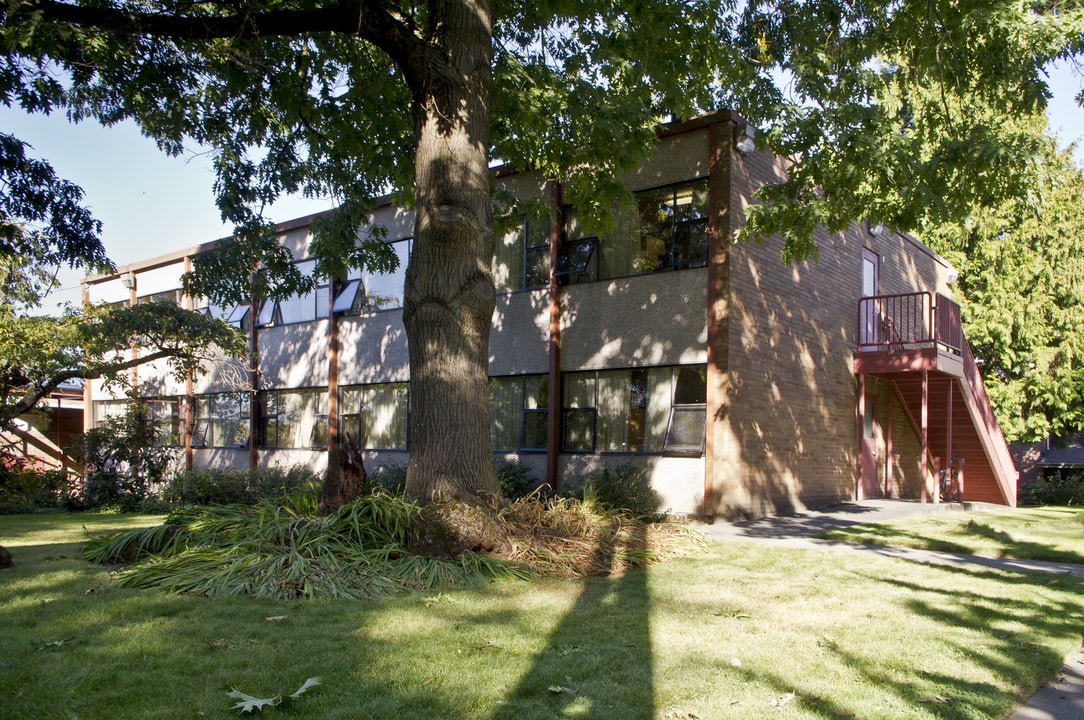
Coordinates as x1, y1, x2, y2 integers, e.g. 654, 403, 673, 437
0, 0, 1084, 497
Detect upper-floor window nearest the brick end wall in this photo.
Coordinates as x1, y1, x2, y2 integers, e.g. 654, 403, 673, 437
565, 180, 708, 280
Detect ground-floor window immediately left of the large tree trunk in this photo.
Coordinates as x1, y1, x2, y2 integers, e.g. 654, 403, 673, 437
339, 383, 410, 450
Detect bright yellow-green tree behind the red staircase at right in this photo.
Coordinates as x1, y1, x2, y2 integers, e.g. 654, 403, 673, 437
924, 128, 1084, 441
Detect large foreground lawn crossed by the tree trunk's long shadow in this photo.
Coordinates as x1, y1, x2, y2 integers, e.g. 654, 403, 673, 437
0, 515, 1084, 720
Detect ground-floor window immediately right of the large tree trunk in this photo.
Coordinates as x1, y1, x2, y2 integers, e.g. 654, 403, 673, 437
489, 375, 550, 452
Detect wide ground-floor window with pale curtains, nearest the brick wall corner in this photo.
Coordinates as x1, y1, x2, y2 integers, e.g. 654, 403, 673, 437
562, 365, 706, 453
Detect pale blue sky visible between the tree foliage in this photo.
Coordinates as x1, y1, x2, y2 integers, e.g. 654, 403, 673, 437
0, 59, 1084, 310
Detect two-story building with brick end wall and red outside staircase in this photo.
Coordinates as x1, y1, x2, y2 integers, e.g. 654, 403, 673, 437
85, 113, 1016, 516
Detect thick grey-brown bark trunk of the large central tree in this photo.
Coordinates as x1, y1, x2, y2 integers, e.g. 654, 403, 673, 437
403, 0, 498, 502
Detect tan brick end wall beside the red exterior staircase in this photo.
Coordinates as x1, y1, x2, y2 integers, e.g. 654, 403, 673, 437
713, 123, 947, 516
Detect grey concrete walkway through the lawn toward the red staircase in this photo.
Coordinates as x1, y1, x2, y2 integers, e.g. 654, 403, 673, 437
695, 500, 1084, 720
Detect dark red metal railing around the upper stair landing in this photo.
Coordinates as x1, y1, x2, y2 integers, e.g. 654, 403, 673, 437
857, 293, 964, 353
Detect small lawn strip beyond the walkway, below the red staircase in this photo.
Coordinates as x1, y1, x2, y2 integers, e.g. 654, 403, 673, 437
817, 507, 1084, 565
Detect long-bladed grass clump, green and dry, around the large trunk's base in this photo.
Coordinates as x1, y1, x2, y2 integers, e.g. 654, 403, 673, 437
83, 485, 704, 600
